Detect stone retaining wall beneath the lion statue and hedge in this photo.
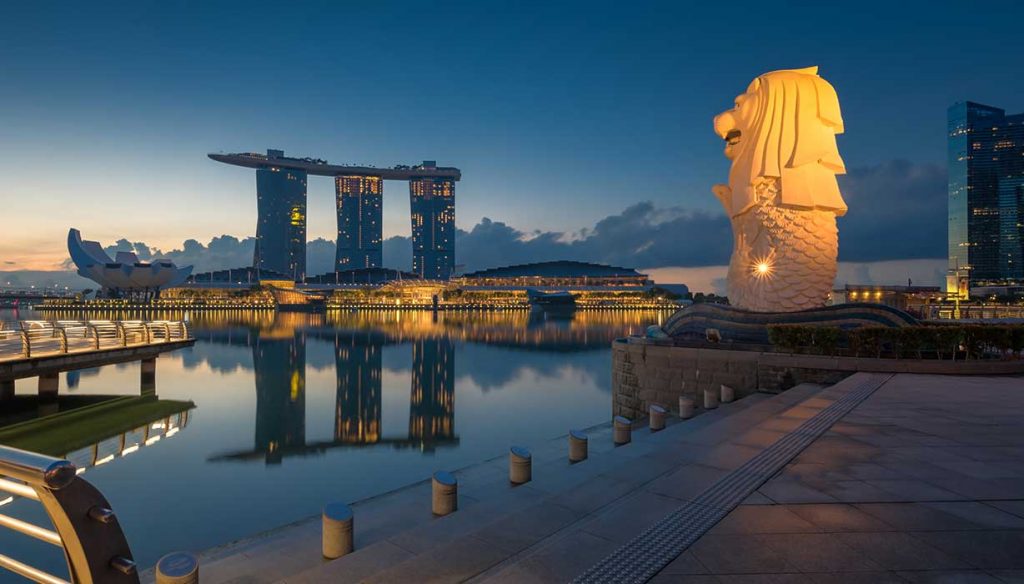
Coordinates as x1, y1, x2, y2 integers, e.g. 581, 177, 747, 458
611, 337, 1024, 419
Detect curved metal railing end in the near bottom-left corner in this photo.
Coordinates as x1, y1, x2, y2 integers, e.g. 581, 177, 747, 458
0, 447, 138, 584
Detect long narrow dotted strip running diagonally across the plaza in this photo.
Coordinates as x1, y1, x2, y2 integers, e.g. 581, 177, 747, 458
573, 373, 892, 584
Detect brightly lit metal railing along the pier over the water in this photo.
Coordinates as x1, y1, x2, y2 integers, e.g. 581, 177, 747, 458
0, 321, 189, 362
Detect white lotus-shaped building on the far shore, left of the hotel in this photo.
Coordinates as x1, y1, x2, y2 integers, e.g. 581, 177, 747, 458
68, 228, 193, 298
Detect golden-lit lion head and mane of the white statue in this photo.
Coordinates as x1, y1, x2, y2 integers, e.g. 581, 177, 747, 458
715, 67, 846, 217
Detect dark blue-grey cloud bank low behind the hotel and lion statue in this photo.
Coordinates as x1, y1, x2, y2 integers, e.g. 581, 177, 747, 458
9, 161, 946, 289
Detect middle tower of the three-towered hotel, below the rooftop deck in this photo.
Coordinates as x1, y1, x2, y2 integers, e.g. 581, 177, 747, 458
334, 176, 384, 269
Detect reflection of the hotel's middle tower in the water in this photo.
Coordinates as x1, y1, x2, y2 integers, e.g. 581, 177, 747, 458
334, 331, 383, 444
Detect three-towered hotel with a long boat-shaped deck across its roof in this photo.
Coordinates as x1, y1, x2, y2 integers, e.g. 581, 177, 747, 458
209, 150, 462, 281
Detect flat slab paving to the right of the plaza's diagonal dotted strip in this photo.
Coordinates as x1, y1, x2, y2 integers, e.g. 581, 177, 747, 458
643, 374, 1024, 583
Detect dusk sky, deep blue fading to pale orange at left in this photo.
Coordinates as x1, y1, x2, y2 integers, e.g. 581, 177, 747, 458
0, 1, 1024, 278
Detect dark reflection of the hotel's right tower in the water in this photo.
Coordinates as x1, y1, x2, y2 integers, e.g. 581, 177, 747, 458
409, 337, 455, 450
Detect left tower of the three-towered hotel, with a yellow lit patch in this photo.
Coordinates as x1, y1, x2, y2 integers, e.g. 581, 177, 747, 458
253, 159, 306, 281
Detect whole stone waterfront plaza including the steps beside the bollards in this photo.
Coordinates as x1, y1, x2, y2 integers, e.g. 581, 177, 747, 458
190, 374, 1024, 583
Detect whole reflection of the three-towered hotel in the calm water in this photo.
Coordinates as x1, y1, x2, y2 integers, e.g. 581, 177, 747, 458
232, 327, 458, 464
